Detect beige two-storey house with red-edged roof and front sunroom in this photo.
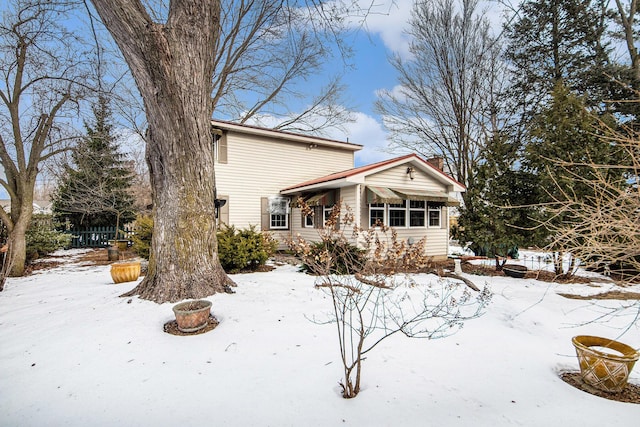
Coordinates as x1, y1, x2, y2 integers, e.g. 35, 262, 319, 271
212, 120, 465, 258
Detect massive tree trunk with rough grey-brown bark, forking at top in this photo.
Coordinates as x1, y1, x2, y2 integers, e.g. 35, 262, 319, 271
93, 0, 232, 303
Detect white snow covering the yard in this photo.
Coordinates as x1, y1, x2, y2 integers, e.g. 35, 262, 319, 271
0, 251, 640, 426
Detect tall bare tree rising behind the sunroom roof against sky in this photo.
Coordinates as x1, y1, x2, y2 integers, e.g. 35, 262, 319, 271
376, 0, 505, 184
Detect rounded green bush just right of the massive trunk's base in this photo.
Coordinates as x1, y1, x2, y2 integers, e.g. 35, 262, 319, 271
218, 226, 278, 273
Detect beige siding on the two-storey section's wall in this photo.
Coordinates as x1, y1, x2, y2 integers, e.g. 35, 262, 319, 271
215, 133, 354, 234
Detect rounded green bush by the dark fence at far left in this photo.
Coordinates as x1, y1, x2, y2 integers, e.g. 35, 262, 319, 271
25, 214, 71, 260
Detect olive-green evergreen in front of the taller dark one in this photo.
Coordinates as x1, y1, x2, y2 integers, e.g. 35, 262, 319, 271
522, 82, 628, 274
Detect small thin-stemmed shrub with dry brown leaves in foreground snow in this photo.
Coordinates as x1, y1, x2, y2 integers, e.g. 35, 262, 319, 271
290, 200, 491, 399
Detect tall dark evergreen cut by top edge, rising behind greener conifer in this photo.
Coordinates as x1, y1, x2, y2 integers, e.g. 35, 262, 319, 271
506, 0, 609, 113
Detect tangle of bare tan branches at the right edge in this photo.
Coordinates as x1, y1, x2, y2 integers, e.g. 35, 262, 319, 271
548, 123, 640, 283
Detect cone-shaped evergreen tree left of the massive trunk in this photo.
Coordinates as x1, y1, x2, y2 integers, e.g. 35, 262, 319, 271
53, 96, 135, 232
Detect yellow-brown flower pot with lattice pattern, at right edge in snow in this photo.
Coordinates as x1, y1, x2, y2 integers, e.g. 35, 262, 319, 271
572, 335, 640, 393
